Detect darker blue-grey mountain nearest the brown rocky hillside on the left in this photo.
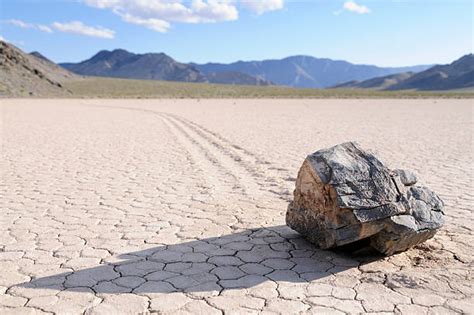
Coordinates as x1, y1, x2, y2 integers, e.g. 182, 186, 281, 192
60, 49, 206, 82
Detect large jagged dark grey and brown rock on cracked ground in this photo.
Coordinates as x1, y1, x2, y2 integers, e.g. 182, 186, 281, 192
286, 142, 444, 255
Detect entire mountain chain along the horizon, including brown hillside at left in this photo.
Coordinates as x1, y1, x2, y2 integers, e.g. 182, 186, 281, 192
0, 41, 474, 96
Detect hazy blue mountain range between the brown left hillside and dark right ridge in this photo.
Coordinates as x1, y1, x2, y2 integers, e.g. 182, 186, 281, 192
60, 49, 429, 88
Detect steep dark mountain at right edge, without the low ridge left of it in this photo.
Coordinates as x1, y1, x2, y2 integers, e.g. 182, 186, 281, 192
388, 54, 474, 90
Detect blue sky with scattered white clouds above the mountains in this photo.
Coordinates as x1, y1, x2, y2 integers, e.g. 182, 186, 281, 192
0, 0, 474, 66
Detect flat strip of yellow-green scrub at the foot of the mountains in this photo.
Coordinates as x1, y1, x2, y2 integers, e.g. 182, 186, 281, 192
64, 77, 474, 98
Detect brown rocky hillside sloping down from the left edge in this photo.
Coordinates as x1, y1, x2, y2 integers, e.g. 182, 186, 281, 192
0, 41, 77, 96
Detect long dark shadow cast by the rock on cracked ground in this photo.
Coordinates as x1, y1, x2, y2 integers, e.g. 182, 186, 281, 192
17, 226, 381, 294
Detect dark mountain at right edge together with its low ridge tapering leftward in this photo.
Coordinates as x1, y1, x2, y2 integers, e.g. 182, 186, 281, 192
335, 54, 474, 91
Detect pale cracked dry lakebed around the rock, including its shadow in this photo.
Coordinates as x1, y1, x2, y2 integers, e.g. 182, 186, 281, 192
0, 100, 474, 314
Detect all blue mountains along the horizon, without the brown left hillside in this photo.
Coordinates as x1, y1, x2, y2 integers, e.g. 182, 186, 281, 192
62, 49, 474, 90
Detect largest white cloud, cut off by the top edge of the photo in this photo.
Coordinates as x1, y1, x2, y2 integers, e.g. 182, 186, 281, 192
82, 0, 284, 32
